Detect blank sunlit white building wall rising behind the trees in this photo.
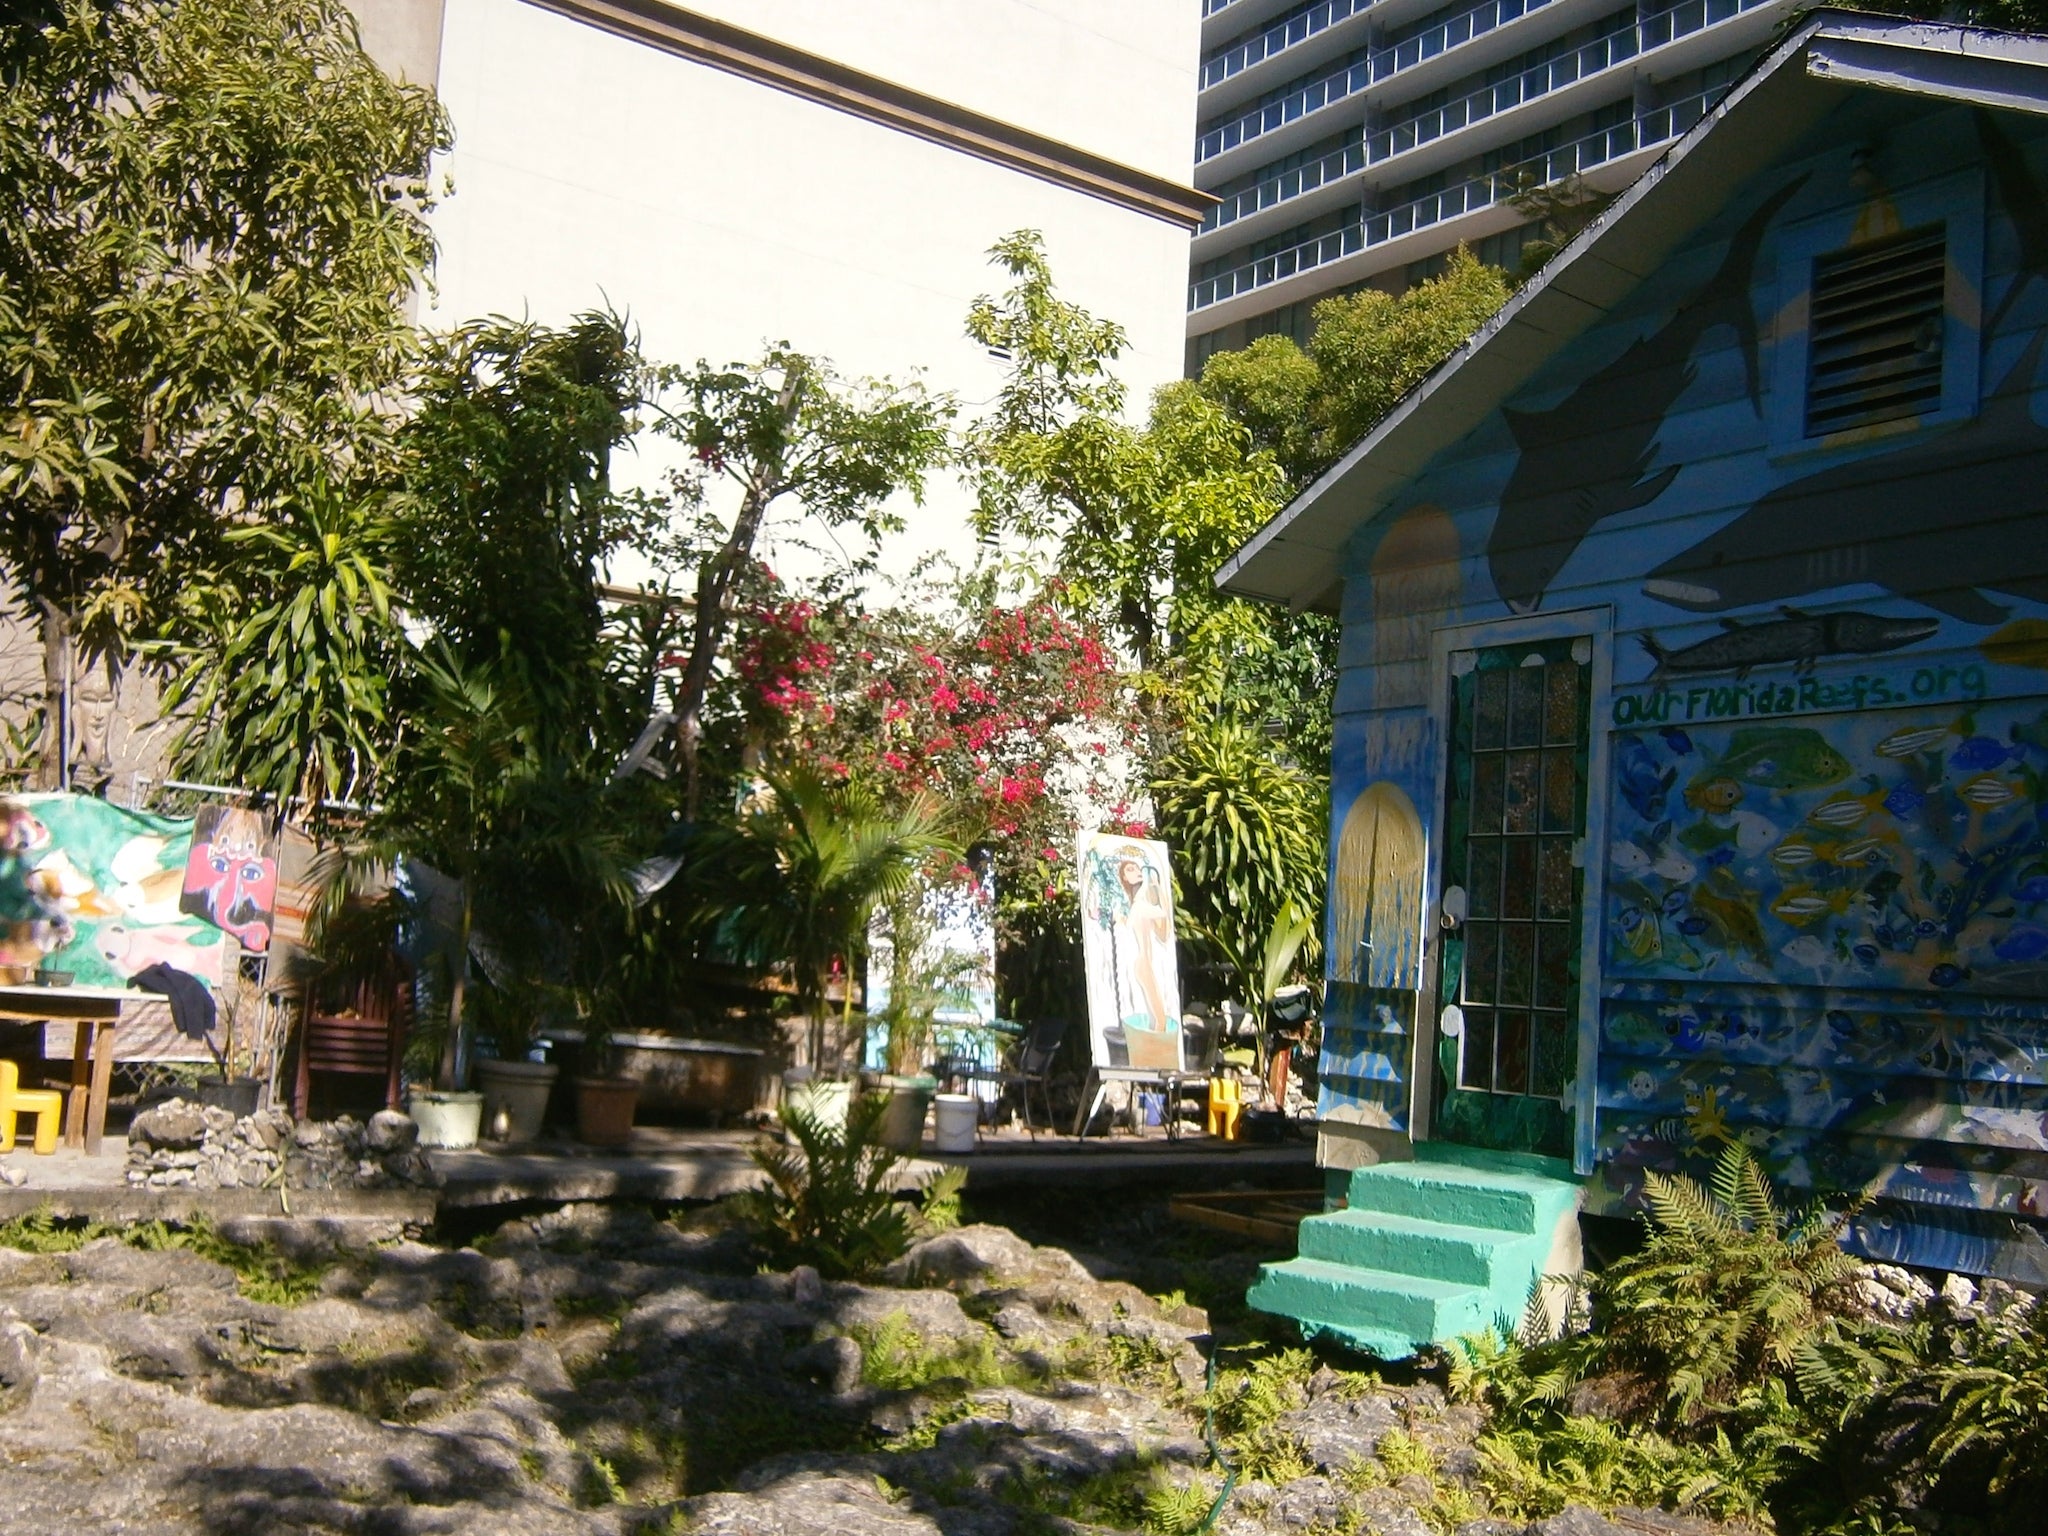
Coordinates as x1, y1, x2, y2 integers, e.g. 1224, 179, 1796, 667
422, 0, 1196, 575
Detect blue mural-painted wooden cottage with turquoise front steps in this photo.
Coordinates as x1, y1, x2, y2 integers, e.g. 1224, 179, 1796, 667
1217, 12, 2048, 1348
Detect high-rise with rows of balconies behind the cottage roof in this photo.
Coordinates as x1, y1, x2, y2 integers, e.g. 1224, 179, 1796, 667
1188, 0, 1800, 373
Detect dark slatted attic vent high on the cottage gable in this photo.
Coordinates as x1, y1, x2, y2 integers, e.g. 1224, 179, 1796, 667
1806, 223, 1948, 438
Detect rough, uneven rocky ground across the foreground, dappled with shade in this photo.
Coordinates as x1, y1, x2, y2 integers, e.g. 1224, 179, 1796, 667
0, 1206, 1744, 1536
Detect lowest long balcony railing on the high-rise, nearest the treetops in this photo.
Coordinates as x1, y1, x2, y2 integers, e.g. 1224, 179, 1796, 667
1188, 88, 1720, 313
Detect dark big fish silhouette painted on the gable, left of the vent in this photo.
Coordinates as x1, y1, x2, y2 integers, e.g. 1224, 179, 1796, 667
1487, 176, 1806, 612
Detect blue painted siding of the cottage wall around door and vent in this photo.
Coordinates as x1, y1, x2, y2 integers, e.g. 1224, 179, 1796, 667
1325, 100, 2048, 1280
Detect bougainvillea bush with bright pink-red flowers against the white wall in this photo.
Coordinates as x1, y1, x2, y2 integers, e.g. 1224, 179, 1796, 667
735, 588, 1143, 1012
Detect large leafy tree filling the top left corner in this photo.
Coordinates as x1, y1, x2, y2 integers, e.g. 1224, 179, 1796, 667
0, 0, 449, 780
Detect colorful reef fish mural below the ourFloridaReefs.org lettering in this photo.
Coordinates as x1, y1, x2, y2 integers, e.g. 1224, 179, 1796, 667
1604, 698, 2048, 997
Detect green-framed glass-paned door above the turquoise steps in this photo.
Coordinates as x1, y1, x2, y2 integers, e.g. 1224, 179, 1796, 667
1432, 637, 1591, 1157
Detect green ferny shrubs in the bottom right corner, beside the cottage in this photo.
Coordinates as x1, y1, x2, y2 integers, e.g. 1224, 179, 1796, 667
1450, 1147, 2048, 1536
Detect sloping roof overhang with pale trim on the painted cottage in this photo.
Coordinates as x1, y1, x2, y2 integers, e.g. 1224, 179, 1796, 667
1214, 10, 2048, 612
